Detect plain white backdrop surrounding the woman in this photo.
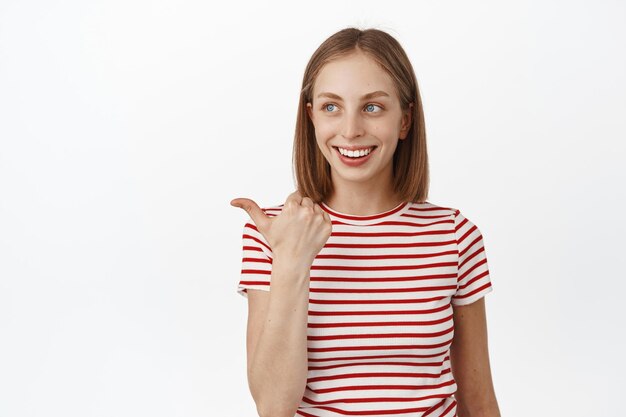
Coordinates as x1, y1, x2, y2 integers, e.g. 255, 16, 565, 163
0, 0, 626, 417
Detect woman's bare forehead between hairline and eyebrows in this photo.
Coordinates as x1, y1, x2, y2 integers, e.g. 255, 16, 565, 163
313, 52, 395, 98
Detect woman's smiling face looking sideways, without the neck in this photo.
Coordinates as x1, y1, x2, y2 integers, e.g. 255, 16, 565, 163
307, 52, 411, 186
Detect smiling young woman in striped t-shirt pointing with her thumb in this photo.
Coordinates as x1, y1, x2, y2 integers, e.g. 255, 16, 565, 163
231, 28, 500, 417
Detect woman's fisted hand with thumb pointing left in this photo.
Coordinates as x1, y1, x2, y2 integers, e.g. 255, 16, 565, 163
230, 191, 332, 268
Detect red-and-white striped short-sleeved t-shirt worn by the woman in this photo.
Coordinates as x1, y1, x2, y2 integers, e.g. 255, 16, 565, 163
237, 202, 492, 417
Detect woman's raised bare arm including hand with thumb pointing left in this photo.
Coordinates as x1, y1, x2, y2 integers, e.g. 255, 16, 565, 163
231, 190, 332, 417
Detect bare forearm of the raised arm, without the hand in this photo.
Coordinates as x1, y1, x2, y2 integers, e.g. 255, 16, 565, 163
246, 258, 310, 417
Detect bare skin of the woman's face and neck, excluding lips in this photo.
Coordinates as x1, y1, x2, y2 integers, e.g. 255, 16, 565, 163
307, 52, 411, 215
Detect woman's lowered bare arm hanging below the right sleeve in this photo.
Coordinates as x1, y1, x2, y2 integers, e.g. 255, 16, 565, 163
450, 297, 500, 417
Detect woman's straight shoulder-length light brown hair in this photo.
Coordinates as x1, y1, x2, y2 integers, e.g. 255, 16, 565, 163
293, 27, 429, 203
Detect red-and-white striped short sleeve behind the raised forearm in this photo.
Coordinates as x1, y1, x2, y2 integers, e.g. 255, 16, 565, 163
237, 218, 273, 298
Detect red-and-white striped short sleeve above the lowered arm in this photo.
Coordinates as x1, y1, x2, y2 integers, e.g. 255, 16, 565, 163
451, 210, 493, 306
